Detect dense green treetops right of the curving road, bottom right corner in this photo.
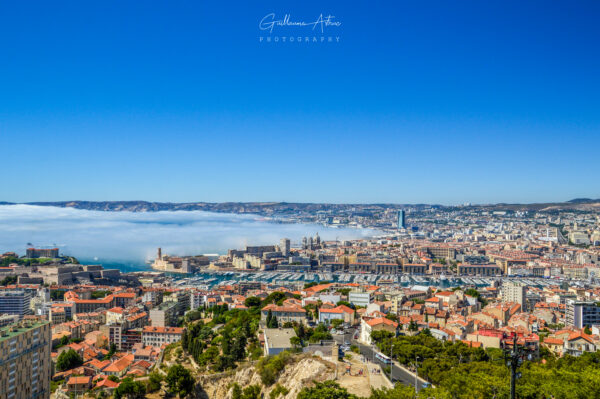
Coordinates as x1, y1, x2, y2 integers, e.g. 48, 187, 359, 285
372, 330, 600, 399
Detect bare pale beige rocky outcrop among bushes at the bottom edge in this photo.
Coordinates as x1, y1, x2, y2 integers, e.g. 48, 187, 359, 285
198, 357, 335, 399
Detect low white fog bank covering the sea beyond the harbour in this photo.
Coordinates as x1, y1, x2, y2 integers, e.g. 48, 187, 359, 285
0, 205, 378, 266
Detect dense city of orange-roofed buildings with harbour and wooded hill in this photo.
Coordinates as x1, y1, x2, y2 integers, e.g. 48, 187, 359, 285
0, 205, 600, 399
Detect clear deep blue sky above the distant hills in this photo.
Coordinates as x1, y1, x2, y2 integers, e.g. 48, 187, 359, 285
0, 0, 600, 204
